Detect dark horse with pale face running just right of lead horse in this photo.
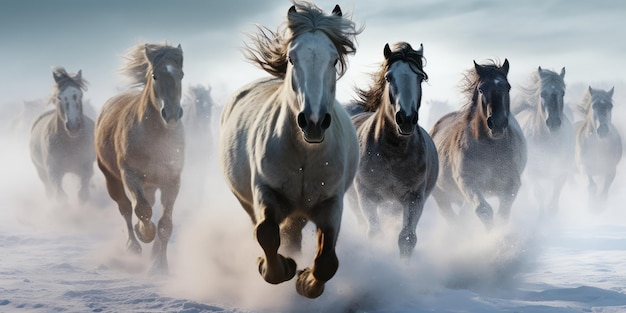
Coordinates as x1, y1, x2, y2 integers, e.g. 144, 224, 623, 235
349, 42, 439, 257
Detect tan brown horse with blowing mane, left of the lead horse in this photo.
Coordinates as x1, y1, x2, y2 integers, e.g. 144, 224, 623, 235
95, 43, 185, 273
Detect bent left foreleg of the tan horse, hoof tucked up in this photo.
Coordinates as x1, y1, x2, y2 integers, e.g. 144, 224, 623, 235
122, 170, 156, 243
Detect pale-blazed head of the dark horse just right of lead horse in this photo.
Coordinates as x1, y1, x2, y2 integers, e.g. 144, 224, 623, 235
383, 42, 428, 135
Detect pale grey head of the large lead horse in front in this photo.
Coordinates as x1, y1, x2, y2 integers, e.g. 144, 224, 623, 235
285, 6, 342, 143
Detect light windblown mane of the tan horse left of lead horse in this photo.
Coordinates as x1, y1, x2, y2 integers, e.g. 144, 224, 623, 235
120, 43, 183, 87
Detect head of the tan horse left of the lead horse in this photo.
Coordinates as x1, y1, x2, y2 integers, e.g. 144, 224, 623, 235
145, 44, 184, 126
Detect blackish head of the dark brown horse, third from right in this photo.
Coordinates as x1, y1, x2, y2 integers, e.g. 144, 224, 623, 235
474, 59, 511, 138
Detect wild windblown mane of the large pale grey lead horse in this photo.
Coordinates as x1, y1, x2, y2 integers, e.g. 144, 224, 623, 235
243, 0, 362, 78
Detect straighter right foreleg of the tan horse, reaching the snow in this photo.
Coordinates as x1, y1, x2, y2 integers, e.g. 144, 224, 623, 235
151, 180, 180, 274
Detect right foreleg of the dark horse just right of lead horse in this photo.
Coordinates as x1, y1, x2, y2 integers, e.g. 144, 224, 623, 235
398, 191, 426, 258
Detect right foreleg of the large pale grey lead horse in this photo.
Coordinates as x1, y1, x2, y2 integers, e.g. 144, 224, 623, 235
296, 198, 343, 298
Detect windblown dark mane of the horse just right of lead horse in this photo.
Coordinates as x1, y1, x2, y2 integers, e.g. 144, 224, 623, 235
354, 41, 428, 112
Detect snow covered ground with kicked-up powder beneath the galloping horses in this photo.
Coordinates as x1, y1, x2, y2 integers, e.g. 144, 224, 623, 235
0, 125, 626, 313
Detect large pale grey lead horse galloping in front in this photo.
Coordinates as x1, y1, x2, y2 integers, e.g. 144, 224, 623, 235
218, 1, 361, 298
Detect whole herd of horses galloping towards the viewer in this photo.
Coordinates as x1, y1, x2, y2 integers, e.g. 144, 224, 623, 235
25, 2, 622, 298
